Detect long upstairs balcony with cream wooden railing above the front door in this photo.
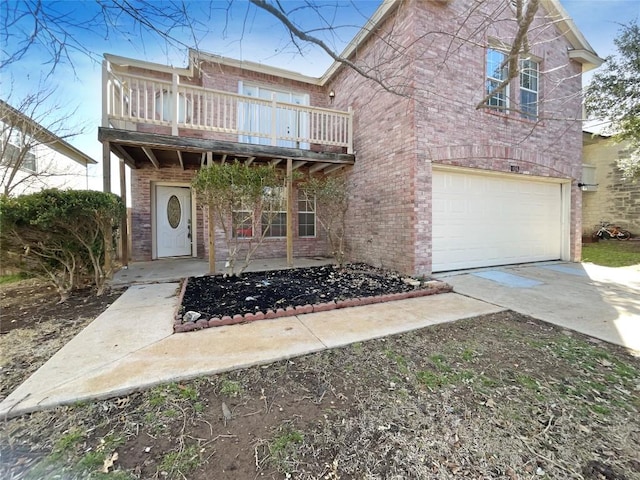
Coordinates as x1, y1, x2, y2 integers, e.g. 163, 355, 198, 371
99, 62, 353, 165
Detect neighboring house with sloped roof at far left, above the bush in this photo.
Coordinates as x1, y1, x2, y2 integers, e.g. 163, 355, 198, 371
0, 100, 97, 195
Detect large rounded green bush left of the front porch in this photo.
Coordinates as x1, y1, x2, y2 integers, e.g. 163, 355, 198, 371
0, 189, 125, 300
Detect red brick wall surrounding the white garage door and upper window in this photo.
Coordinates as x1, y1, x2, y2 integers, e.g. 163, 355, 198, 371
330, 0, 582, 274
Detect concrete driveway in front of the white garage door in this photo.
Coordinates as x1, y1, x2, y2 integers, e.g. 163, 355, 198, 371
435, 262, 640, 354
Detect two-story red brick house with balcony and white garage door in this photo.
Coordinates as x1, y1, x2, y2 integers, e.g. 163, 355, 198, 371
99, 0, 601, 275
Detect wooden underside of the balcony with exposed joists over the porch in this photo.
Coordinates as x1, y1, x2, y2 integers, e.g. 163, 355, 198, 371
98, 127, 355, 173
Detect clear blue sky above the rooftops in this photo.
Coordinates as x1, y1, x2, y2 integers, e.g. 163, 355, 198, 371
0, 0, 640, 189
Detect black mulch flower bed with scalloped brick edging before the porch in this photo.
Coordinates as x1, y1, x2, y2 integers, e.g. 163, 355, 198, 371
174, 264, 452, 332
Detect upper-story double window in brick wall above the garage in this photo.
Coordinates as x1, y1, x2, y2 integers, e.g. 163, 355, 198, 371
485, 47, 540, 120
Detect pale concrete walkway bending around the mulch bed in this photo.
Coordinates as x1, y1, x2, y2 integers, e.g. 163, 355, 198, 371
0, 282, 504, 418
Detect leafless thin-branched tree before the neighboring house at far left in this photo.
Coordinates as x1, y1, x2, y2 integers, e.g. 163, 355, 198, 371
0, 89, 82, 195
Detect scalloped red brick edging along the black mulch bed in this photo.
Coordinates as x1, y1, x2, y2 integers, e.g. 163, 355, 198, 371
173, 278, 453, 333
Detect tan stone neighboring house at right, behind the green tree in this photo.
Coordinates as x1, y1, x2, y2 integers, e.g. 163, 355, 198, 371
582, 122, 640, 235
